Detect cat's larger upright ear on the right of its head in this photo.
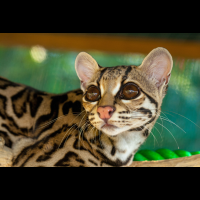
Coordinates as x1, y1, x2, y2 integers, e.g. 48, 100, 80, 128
139, 47, 173, 88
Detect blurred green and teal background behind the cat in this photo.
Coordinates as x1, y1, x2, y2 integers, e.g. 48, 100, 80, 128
0, 34, 200, 151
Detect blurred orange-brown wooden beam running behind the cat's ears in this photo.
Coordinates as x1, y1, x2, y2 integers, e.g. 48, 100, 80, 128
0, 33, 200, 58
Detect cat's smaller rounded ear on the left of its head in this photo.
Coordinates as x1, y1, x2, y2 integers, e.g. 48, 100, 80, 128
75, 52, 99, 90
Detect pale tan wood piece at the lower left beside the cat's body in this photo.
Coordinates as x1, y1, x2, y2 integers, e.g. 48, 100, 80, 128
0, 137, 13, 167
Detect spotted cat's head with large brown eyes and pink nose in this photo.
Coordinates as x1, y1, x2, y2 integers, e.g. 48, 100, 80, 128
75, 47, 173, 136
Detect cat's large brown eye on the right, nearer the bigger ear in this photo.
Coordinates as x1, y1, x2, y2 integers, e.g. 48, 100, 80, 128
120, 83, 140, 100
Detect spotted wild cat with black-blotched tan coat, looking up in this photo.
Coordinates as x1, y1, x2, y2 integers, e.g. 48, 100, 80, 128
0, 47, 173, 167
